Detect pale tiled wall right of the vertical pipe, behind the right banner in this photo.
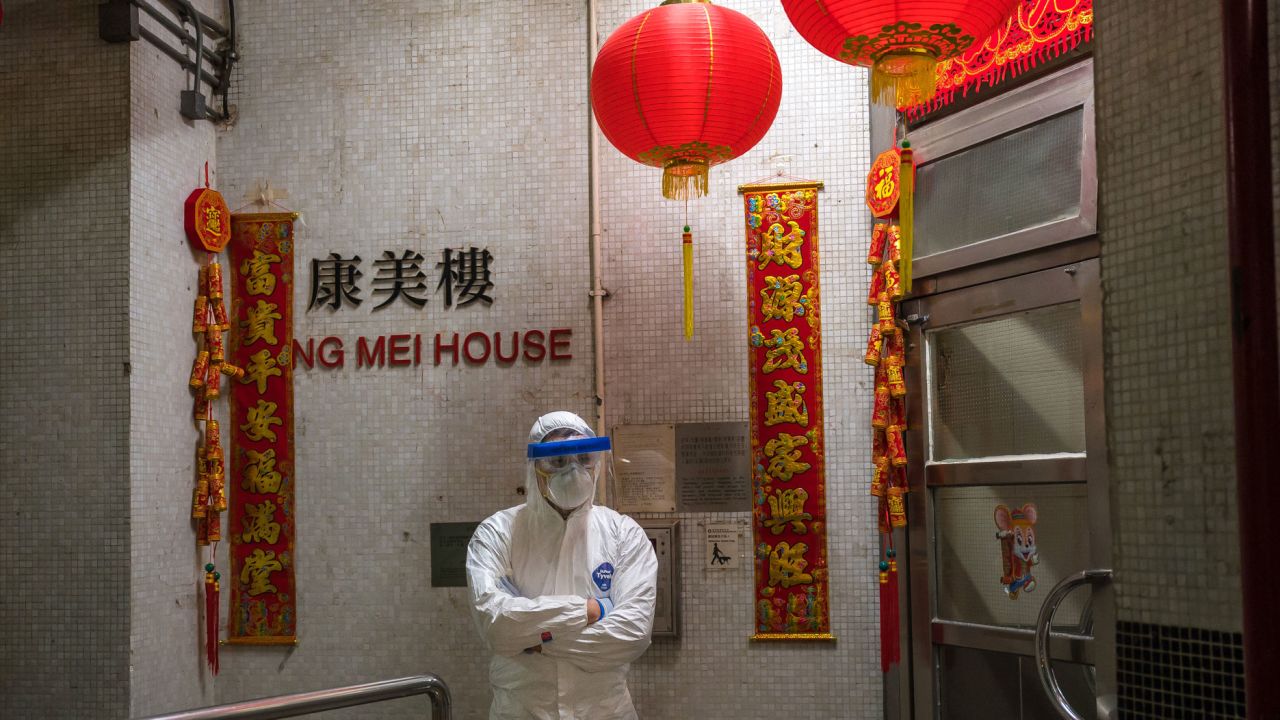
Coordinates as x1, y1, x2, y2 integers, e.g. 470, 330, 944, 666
600, 0, 881, 719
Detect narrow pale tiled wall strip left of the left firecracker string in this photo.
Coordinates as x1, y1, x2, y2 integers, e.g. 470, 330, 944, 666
127, 0, 225, 716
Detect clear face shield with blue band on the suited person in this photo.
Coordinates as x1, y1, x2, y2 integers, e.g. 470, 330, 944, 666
527, 432, 613, 516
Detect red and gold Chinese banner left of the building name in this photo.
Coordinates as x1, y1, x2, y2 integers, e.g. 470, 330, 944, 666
224, 213, 297, 644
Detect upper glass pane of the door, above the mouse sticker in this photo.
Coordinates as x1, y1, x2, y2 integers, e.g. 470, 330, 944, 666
927, 302, 1084, 461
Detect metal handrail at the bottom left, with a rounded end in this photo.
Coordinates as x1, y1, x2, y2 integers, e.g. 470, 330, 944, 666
138, 675, 453, 720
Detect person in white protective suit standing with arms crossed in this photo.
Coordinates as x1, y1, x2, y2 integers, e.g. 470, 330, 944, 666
467, 413, 658, 720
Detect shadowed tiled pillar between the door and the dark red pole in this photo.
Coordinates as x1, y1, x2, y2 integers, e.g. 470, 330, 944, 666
1094, 0, 1239, 632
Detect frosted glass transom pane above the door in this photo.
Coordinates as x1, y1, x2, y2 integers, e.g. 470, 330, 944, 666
915, 108, 1084, 258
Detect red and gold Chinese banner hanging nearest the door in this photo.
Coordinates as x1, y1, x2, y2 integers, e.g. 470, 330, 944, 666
740, 182, 832, 639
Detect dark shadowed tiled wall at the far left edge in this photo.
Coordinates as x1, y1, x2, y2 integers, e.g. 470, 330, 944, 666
0, 0, 131, 717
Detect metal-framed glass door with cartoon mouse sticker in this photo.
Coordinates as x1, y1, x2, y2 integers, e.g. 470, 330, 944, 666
904, 260, 1115, 720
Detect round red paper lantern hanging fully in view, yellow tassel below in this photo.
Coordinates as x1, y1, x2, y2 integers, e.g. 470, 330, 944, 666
591, 0, 782, 199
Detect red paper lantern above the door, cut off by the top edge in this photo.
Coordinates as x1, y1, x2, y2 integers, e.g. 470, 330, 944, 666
782, 0, 1018, 108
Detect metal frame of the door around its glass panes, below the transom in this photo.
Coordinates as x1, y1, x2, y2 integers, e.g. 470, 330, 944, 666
902, 254, 1116, 720
